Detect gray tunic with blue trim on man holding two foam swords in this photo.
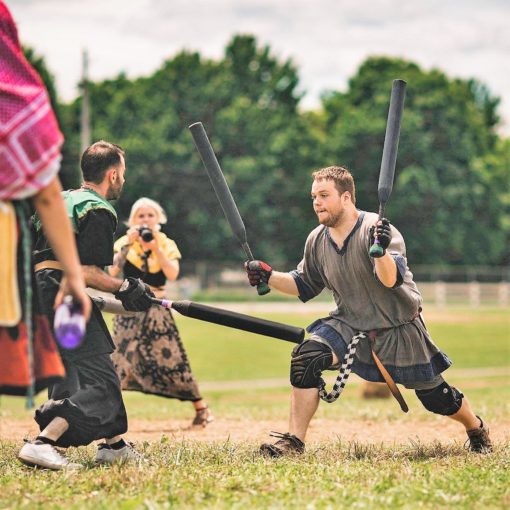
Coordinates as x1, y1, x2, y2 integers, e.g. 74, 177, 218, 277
291, 211, 451, 387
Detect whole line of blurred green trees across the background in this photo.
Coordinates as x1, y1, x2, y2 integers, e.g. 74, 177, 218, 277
24, 35, 510, 268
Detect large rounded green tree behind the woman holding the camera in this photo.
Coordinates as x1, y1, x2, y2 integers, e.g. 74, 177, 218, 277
59, 36, 313, 262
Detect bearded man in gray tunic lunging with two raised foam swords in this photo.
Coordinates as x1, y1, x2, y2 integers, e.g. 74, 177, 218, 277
245, 166, 492, 457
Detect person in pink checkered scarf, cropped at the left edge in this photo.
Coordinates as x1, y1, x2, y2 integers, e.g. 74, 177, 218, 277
0, 1, 91, 402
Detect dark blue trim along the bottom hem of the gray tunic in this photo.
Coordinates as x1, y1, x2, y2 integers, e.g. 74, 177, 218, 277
306, 319, 452, 384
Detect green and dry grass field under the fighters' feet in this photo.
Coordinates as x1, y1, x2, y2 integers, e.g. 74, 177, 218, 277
0, 309, 510, 509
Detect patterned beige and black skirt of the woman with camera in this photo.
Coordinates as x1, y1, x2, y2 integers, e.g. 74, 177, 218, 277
112, 306, 202, 402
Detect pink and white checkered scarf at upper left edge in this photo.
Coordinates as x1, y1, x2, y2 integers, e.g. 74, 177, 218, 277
0, 1, 63, 200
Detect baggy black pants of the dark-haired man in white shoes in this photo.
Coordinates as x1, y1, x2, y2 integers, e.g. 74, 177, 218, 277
35, 354, 127, 448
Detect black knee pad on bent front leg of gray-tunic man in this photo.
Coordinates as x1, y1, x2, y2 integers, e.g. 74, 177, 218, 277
290, 340, 333, 388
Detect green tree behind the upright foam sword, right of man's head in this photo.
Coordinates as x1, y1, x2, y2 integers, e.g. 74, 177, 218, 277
323, 57, 506, 264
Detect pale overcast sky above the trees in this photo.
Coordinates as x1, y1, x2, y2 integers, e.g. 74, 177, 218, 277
6, 0, 510, 134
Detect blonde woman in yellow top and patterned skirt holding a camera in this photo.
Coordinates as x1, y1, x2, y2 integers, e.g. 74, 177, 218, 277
109, 198, 214, 427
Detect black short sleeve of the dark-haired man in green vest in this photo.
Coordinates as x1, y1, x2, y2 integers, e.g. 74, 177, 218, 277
76, 209, 116, 267
